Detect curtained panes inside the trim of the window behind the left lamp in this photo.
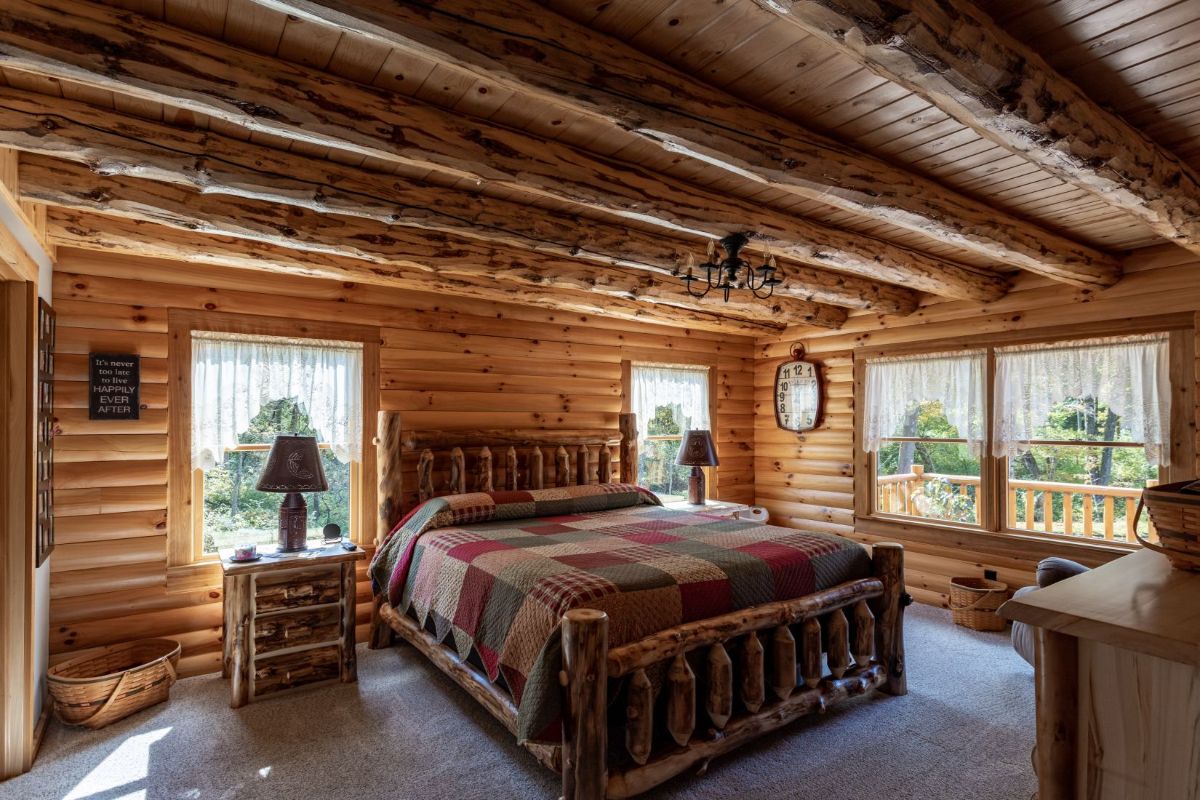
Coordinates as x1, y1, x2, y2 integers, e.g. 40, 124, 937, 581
191, 331, 362, 555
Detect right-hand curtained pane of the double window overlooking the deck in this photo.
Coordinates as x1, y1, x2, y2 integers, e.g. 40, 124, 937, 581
994, 335, 1171, 542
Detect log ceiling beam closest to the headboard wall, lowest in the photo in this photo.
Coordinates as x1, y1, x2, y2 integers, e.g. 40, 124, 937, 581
47, 207, 784, 336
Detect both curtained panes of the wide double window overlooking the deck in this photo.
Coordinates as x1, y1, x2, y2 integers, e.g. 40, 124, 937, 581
857, 333, 1171, 551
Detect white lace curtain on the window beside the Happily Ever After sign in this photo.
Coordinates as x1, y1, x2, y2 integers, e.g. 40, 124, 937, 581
192, 331, 362, 470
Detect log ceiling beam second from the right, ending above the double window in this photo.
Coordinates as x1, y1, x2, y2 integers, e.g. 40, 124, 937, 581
254, 0, 1121, 285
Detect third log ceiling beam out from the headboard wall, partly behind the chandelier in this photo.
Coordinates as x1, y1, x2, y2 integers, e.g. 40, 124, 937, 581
0, 90, 918, 314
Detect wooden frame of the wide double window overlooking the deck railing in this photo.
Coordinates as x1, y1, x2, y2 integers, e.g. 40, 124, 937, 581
853, 314, 1196, 553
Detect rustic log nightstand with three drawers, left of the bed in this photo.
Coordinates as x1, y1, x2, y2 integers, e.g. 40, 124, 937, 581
221, 545, 366, 709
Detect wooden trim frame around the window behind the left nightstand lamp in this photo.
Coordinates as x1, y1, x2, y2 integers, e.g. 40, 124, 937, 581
167, 308, 380, 578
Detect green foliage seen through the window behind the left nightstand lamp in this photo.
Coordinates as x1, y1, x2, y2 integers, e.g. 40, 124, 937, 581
204, 399, 350, 553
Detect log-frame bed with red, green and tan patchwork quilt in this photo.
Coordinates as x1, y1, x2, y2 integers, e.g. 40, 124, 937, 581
371, 411, 908, 800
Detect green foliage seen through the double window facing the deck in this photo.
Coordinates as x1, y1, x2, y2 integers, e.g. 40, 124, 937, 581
877, 397, 1158, 540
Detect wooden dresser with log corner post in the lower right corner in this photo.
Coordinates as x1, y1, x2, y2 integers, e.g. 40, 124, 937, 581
1000, 551, 1200, 800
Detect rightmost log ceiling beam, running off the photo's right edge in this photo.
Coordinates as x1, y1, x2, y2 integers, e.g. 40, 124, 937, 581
755, 0, 1200, 253
